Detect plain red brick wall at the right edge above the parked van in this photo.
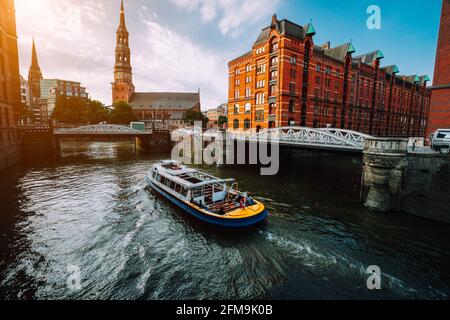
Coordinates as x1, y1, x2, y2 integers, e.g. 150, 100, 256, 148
428, 0, 450, 136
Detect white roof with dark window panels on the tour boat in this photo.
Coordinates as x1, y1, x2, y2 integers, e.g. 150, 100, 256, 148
154, 160, 236, 189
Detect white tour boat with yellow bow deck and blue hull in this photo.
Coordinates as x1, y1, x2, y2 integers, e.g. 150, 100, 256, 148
145, 160, 268, 227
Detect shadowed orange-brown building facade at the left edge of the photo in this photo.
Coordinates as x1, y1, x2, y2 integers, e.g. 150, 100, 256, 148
0, 0, 21, 170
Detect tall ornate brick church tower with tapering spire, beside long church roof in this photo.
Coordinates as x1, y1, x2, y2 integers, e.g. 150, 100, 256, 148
112, 0, 134, 103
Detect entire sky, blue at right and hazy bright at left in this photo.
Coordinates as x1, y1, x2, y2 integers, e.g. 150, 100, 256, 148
15, 0, 442, 110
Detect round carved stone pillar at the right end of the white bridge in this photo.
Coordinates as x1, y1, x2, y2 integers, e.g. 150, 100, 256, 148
361, 138, 408, 212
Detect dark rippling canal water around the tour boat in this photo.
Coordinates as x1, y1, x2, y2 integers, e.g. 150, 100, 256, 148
0, 142, 450, 299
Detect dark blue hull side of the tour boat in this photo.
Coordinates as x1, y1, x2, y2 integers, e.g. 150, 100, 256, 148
145, 177, 268, 228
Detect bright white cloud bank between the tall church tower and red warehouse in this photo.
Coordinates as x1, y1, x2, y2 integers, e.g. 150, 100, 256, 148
132, 17, 228, 108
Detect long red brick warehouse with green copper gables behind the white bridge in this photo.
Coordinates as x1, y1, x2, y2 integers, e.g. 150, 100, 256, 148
228, 16, 431, 137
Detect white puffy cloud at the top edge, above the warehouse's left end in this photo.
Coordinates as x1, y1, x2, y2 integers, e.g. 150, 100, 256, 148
172, 0, 281, 37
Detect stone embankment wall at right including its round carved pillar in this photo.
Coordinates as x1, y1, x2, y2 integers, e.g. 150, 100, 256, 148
361, 138, 450, 223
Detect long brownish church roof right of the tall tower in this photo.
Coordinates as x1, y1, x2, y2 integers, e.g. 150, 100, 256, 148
130, 92, 200, 111
